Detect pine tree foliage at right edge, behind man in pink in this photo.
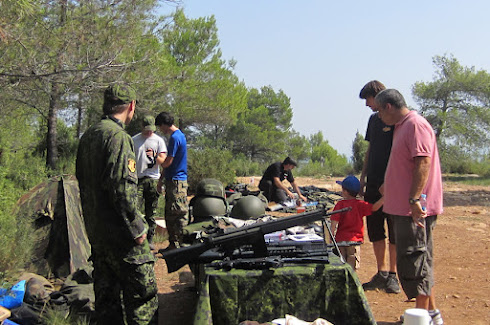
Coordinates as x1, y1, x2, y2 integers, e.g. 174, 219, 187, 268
413, 56, 490, 157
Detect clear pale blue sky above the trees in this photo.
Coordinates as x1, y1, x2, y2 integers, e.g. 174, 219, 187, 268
162, 0, 490, 158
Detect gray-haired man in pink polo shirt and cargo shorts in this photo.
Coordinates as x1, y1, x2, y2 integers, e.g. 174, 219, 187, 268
375, 89, 443, 325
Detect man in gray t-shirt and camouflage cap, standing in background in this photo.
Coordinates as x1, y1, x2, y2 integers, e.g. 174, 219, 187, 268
133, 115, 167, 249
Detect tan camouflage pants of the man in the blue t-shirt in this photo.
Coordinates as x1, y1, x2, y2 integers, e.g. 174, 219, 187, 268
165, 179, 189, 245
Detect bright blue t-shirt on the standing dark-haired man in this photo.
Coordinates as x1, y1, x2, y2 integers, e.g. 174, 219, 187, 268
165, 129, 187, 181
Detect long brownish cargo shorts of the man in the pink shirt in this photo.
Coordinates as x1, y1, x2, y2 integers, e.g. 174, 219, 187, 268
392, 216, 437, 299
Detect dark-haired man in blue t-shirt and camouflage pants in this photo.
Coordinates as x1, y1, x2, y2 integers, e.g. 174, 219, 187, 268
155, 112, 189, 249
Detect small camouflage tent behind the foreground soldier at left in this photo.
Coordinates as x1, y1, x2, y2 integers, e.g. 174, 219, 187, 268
17, 175, 91, 278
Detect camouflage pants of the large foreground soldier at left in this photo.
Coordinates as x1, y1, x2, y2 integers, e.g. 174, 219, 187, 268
92, 251, 158, 325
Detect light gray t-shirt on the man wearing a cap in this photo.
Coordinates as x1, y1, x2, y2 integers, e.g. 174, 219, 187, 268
133, 133, 167, 179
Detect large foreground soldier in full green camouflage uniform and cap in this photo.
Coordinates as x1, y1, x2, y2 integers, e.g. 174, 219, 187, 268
76, 84, 158, 325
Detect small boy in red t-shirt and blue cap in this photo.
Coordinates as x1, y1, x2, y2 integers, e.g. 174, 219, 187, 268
330, 175, 383, 270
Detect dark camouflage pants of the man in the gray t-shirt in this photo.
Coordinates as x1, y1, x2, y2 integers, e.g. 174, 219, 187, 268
138, 177, 160, 244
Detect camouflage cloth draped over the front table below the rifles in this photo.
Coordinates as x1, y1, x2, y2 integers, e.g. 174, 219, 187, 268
194, 256, 376, 325
